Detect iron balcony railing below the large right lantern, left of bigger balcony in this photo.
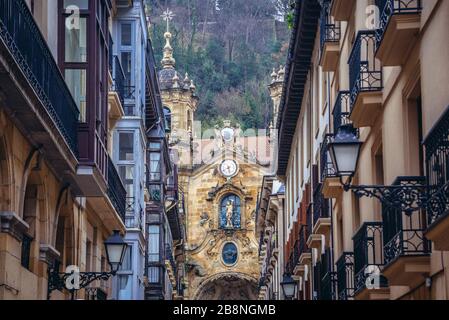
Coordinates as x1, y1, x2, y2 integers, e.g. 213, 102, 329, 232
352, 222, 388, 293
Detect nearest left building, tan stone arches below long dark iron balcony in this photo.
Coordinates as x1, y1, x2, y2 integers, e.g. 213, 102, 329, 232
0, 1, 130, 299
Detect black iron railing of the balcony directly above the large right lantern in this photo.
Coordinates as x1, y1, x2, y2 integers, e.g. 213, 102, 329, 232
348, 31, 383, 108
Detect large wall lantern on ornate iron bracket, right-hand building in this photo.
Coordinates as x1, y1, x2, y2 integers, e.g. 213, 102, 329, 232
329, 124, 428, 213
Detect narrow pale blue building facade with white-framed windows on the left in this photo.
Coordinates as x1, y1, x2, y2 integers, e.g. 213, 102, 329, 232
111, 1, 147, 300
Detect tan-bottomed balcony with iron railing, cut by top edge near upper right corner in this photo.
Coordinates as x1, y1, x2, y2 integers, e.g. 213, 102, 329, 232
376, 0, 422, 66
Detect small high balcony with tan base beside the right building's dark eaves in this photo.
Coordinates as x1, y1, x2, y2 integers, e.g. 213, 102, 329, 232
320, 0, 341, 72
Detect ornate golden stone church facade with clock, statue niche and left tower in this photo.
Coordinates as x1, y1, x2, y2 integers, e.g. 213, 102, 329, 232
159, 25, 273, 300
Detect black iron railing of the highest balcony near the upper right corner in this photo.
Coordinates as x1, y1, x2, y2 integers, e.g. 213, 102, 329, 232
376, 0, 422, 48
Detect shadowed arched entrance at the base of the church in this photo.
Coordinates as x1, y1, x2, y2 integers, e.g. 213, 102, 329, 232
194, 272, 258, 300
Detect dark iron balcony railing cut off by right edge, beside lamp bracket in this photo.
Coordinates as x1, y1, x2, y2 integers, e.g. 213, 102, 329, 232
424, 107, 449, 227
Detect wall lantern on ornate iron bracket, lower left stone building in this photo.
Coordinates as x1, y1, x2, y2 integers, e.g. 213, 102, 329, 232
47, 230, 128, 300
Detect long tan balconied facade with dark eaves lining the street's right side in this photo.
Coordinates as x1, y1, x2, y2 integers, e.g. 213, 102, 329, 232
268, 0, 449, 300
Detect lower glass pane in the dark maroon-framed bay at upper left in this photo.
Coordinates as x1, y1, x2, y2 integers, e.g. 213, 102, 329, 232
65, 69, 87, 122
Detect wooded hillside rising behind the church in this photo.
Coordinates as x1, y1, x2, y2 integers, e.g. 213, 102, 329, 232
147, 0, 290, 129
